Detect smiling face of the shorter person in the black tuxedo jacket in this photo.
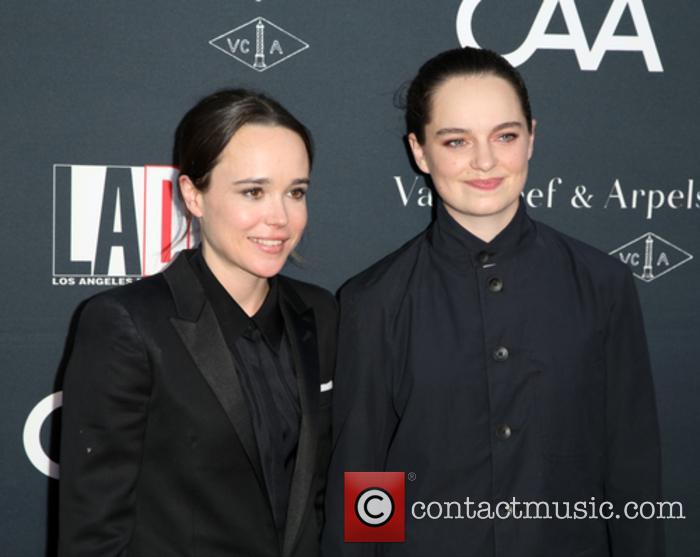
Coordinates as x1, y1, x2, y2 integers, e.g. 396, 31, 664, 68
180, 124, 309, 280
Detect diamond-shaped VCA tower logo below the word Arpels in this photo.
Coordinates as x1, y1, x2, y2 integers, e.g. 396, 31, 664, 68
610, 232, 693, 282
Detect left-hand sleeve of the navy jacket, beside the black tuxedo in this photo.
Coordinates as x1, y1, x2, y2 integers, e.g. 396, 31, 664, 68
322, 289, 398, 557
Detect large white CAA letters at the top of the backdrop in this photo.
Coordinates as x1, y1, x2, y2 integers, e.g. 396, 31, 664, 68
457, 0, 663, 72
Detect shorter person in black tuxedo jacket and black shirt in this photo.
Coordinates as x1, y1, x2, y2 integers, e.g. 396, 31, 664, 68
59, 90, 336, 557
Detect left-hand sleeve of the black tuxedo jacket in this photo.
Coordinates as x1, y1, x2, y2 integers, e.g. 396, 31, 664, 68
58, 297, 151, 557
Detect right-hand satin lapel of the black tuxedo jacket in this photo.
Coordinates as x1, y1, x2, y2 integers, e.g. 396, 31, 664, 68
279, 277, 320, 556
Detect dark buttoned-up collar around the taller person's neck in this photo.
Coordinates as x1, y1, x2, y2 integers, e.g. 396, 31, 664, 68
430, 198, 535, 267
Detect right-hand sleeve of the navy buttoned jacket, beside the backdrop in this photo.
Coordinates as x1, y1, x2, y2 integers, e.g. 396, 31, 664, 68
605, 269, 665, 557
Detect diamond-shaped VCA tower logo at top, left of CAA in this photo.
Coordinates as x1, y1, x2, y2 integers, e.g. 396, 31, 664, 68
209, 17, 309, 72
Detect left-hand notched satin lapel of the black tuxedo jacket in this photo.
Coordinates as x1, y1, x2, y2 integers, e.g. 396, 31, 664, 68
164, 250, 267, 484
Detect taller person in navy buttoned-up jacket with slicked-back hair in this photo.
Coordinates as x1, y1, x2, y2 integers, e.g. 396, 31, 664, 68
324, 48, 664, 557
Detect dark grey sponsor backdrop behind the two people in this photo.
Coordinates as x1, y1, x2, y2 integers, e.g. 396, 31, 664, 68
0, 0, 700, 557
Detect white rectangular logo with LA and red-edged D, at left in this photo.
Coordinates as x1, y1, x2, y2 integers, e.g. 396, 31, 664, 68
53, 164, 195, 285
